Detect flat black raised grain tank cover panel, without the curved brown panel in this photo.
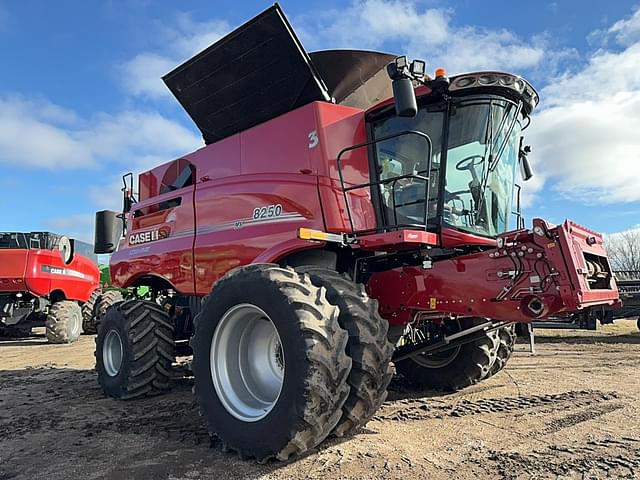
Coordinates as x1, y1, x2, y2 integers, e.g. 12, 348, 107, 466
163, 4, 331, 143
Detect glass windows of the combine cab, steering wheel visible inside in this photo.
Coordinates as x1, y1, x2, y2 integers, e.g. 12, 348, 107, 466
374, 96, 522, 237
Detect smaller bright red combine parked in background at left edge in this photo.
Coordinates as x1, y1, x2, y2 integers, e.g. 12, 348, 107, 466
0, 232, 100, 343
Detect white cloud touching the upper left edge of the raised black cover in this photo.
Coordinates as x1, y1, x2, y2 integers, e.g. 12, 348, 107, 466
119, 13, 231, 98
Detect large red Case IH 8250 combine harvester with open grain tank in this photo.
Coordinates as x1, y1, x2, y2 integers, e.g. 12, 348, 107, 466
96, 4, 618, 461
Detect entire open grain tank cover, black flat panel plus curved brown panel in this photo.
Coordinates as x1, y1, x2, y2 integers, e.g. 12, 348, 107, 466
163, 3, 395, 143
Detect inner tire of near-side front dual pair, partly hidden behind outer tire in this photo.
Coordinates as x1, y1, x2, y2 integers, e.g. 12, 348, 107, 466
297, 266, 393, 437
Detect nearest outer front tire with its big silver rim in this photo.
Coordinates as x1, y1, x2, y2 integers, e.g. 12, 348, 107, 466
192, 265, 351, 462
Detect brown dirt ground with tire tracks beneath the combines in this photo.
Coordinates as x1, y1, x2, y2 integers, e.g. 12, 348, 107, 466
0, 321, 640, 480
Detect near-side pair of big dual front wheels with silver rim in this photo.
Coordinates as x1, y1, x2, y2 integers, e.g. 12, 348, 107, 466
192, 265, 392, 462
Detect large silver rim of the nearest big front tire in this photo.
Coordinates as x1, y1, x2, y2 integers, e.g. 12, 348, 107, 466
209, 303, 285, 422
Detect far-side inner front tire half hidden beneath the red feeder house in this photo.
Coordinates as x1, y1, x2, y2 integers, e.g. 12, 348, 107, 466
396, 318, 498, 392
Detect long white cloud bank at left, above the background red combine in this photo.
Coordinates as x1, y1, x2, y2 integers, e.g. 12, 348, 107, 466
0, 96, 201, 168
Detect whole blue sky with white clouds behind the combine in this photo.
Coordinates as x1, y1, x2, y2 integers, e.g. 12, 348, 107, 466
0, 0, 640, 240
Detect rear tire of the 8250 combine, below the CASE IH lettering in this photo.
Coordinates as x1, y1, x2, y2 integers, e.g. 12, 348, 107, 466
96, 300, 175, 400
